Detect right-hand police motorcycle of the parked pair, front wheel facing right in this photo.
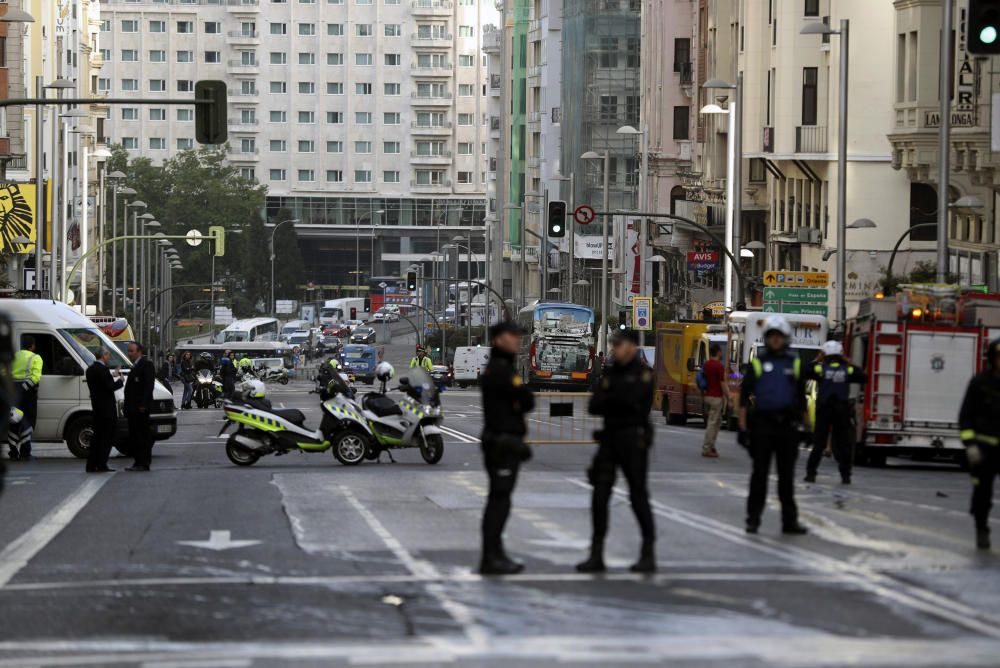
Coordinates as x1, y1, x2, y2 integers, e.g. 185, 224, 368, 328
352, 362, 444, 464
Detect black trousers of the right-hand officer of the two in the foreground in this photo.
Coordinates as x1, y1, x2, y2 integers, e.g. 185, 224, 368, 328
587, 427, 656, 548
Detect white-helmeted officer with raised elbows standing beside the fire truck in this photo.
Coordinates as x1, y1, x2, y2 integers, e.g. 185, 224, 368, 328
806, 341, 868, 485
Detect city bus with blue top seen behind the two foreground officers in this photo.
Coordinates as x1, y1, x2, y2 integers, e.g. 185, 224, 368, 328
518, 302, 596, 392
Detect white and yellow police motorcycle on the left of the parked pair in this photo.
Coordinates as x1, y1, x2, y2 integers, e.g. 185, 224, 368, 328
219, 374, 367, 466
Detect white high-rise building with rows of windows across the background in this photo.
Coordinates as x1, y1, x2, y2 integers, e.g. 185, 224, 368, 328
99, 0, 498, 293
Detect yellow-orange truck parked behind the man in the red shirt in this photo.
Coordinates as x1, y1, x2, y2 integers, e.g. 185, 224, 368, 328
653, 321, 726, 424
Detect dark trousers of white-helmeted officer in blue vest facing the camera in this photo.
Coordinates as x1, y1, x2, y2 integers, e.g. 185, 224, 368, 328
747, 412, 799, 527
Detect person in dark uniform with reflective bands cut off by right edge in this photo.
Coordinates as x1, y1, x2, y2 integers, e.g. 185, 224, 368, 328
958, 339, 1000, 550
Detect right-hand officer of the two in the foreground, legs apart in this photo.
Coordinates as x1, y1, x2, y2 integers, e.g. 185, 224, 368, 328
576, 330, 656, 573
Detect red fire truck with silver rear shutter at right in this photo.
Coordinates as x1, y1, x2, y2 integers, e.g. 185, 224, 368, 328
844, 284, 1000, 466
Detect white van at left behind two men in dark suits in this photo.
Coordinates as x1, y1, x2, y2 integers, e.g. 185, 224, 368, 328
0, 299, 177, 459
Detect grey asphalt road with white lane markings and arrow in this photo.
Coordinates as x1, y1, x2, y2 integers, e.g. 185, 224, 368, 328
0, 343, 1000, 668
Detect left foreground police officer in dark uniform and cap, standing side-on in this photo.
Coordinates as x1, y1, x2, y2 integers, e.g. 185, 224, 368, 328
479, 321, 535, 575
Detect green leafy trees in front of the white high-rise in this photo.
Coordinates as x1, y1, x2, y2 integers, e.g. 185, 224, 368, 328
108, 146, 268, 317
